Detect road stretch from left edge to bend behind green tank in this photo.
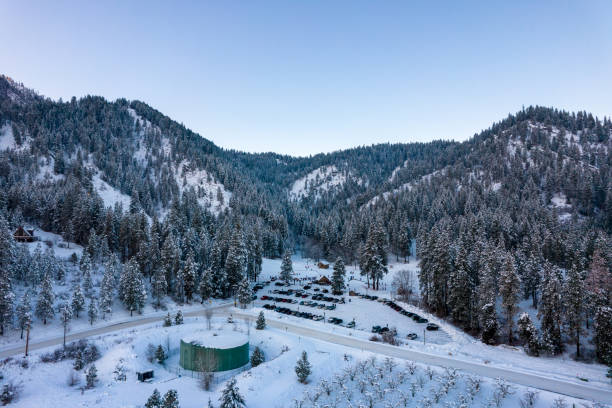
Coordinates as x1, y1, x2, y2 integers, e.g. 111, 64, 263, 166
0, 303, 233, 358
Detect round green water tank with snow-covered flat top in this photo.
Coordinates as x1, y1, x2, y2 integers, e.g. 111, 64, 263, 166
179, 330, 249, 372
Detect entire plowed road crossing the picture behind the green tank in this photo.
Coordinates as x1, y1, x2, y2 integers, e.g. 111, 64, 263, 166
0, 303, 612, 404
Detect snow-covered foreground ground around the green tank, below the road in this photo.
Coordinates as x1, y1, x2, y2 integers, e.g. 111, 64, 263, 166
2, 317, 604, 408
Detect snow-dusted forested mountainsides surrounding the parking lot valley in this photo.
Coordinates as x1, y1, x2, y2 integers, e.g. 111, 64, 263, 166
0, 77, 612, 362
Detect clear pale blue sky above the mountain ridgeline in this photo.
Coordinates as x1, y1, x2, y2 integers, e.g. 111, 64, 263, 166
0, 0, 612, 155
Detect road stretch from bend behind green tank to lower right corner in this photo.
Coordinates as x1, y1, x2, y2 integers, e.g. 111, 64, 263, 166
232, 311, 612, 404
